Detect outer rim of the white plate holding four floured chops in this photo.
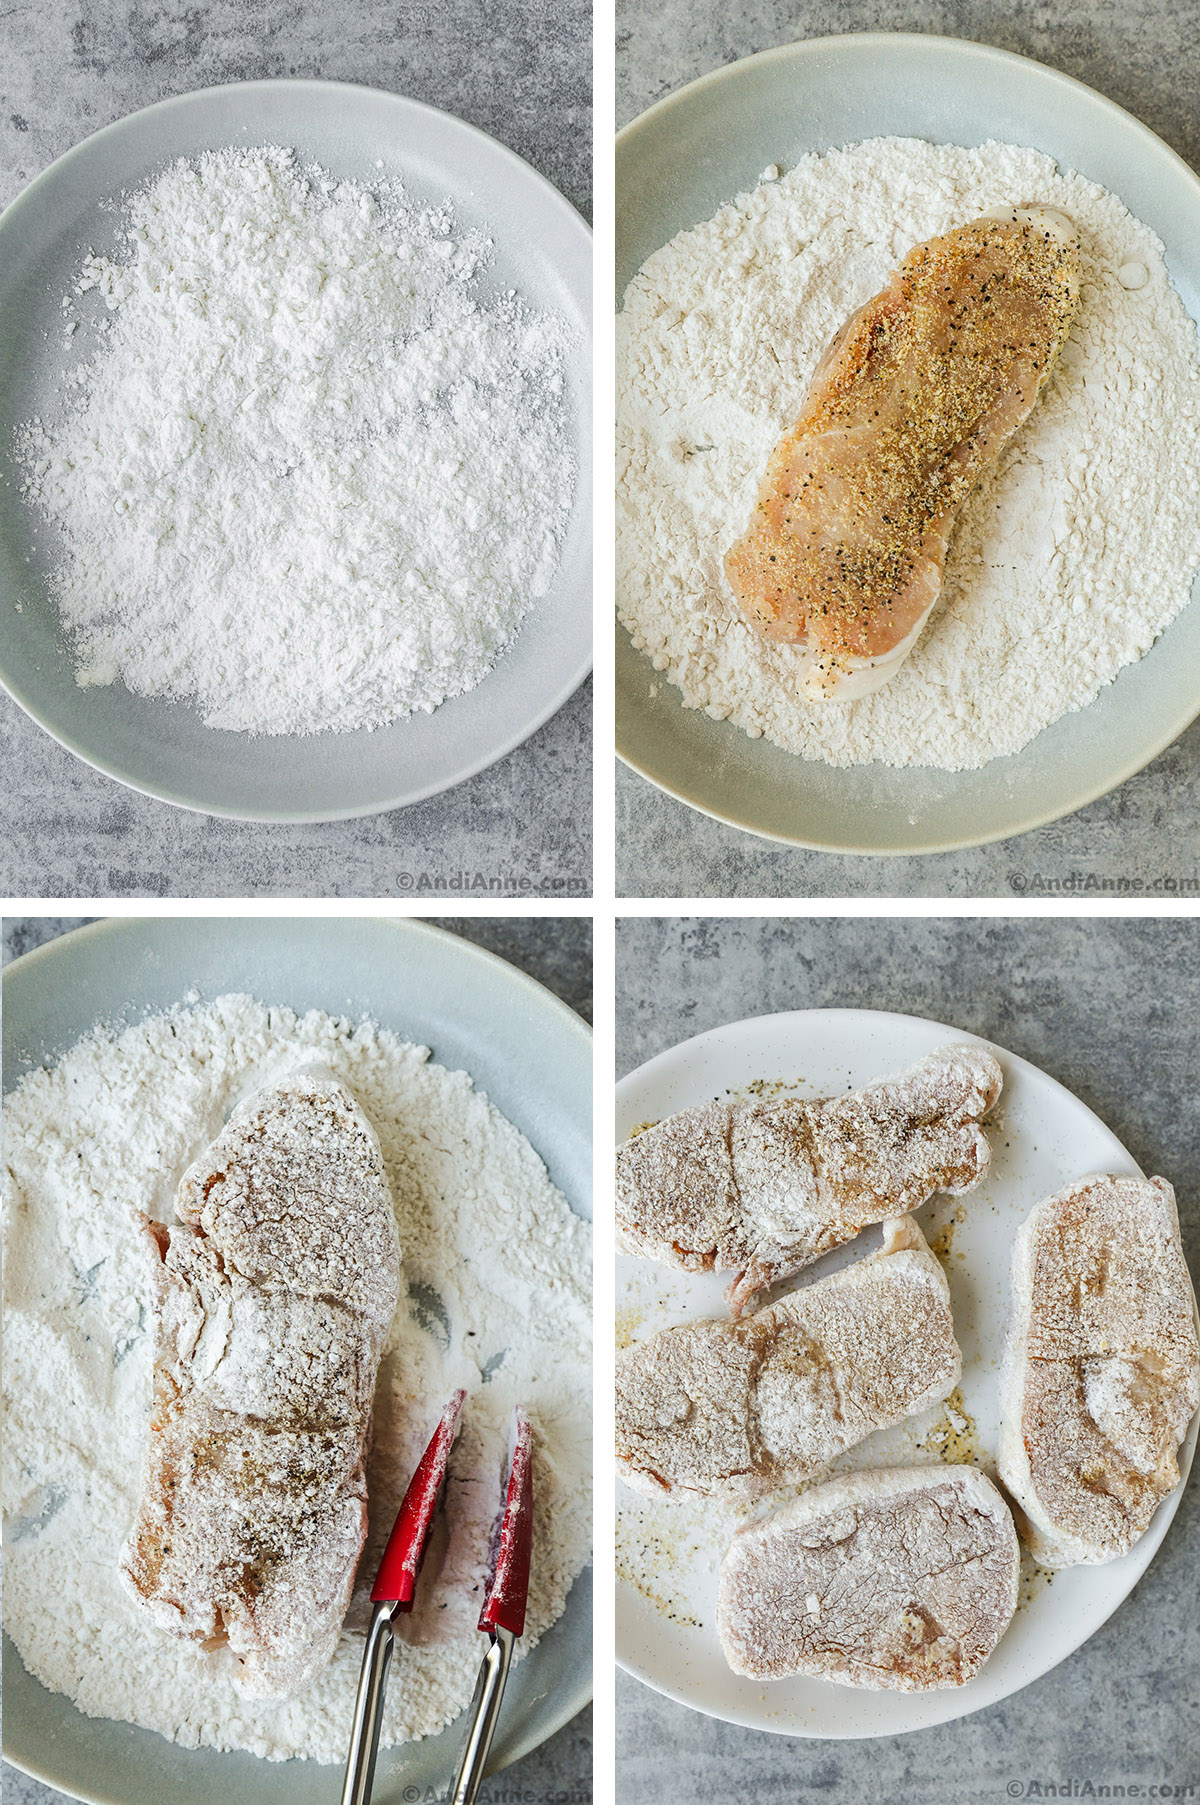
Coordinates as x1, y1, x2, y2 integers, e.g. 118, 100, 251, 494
614, 1005, 1200, 1742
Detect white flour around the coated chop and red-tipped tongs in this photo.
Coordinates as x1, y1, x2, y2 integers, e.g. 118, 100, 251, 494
4, 996, 592, 1762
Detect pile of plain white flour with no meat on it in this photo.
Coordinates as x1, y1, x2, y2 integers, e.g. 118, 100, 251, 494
18, 148, 576, 733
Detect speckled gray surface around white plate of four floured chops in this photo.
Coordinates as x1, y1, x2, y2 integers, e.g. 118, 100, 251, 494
617, 917, 1200, 1805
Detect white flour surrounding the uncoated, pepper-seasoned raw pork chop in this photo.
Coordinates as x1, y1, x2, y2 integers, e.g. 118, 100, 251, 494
617, 139, 1200, 771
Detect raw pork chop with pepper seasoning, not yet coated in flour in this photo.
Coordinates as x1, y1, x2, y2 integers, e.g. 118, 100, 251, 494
725, 206, 1081, 700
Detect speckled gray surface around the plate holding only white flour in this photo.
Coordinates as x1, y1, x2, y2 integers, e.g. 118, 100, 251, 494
0, 0, 592, 897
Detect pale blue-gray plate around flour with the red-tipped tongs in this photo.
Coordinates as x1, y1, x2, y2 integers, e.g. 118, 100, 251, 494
4, 919, 592, 1805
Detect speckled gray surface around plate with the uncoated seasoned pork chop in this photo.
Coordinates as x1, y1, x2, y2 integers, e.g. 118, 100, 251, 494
617, 0, 1200, 897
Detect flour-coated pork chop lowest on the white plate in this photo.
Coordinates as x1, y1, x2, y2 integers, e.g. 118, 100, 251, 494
716, 1466, 1021, 1691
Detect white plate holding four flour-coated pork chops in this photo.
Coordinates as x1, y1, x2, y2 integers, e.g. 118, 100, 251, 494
617, 1009, 1196, 1736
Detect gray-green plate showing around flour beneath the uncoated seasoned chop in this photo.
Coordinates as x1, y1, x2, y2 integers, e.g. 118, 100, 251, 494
617, 32, 1200, 852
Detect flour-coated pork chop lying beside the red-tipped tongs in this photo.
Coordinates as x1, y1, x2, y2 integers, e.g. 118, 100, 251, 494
123, 1072, 401, 1697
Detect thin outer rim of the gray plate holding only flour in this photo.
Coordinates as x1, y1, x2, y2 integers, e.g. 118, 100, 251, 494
0, 76, 594, 825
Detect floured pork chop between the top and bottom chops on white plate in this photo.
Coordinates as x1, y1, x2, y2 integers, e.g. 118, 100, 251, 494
617, 1217, 962, 1504
